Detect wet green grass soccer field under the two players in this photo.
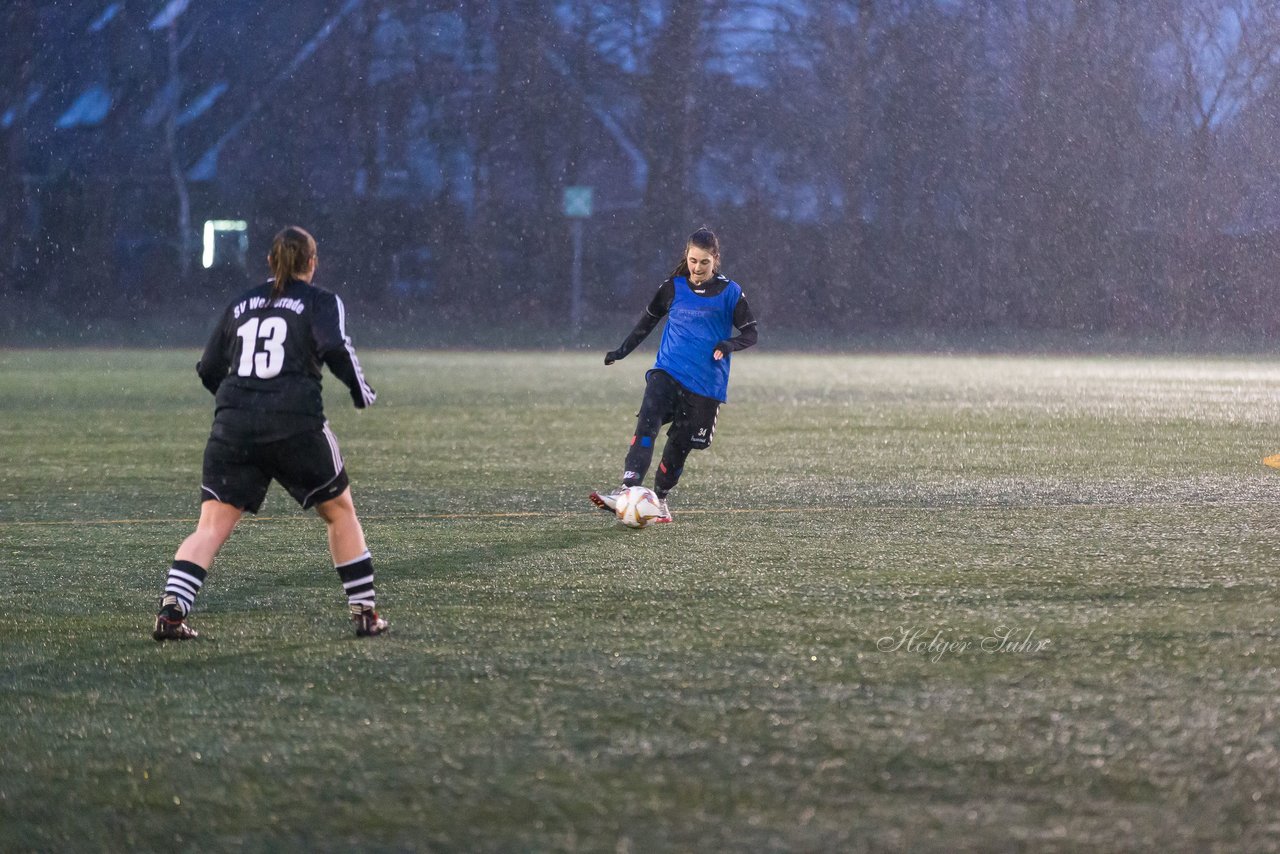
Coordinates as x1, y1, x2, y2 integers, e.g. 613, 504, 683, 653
0, 351, 1280, 853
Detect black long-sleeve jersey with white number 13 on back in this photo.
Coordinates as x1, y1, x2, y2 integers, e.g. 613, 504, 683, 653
196, 279, 378, 442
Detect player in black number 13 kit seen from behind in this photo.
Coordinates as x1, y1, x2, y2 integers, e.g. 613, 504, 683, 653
152, 227, 387, 640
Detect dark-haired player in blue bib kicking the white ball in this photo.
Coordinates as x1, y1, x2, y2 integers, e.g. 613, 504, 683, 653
590, 227, 756, 522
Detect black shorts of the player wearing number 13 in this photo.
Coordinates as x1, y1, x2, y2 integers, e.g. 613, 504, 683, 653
200, 424, 349, 513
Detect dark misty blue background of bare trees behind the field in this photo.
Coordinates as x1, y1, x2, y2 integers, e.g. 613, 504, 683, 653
0, 0, 1280, 348
